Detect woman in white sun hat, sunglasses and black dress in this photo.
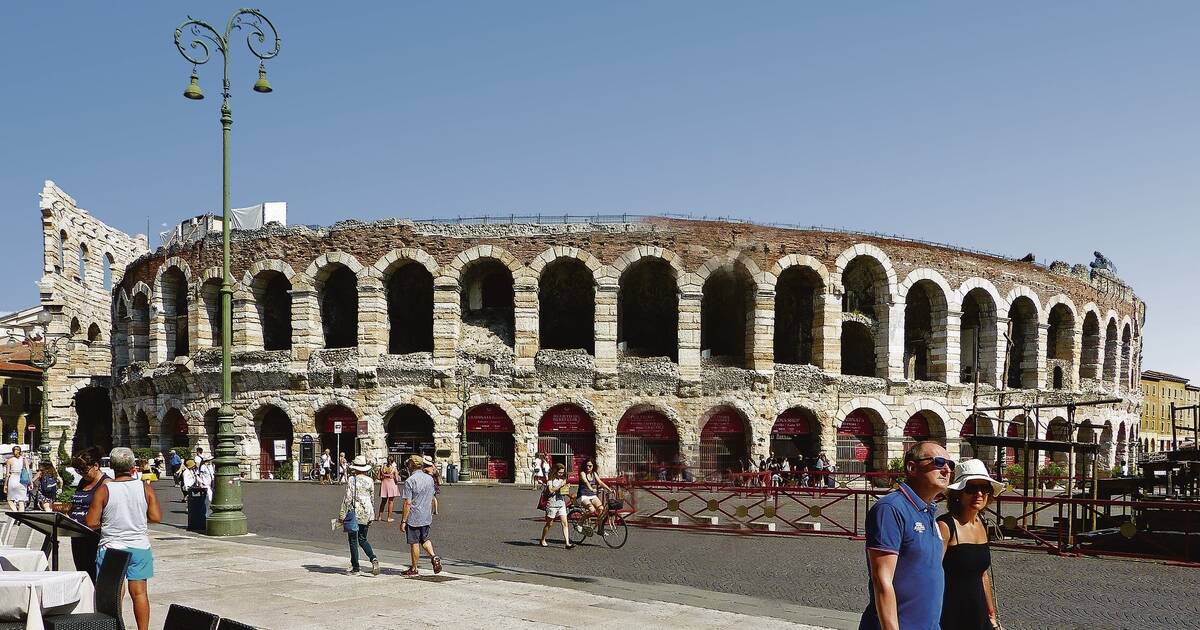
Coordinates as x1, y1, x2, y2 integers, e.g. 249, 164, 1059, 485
937, 460, 1004, 630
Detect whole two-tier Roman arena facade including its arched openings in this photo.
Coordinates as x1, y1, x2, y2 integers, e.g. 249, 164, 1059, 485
35, 181, 1145, 481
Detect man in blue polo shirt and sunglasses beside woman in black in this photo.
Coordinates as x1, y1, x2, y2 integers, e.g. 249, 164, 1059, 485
858, 442, 954, 630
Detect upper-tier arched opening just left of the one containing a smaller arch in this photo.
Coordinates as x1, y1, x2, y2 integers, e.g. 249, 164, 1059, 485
775, 265, 824, 364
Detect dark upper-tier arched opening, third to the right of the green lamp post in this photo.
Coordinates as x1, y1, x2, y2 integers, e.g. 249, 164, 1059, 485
388, 262, 433, 354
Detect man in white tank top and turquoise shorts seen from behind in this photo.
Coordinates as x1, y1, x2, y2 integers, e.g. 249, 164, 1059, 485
88, 446, 162, 630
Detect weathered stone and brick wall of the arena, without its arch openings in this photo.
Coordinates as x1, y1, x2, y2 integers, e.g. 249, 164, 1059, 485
93, 213, 1145, 480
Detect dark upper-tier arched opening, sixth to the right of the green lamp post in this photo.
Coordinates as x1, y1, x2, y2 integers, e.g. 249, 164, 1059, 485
617, 258, 679, 361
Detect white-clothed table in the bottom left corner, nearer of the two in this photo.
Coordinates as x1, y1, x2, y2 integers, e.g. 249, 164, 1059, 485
0, 571, 96, 630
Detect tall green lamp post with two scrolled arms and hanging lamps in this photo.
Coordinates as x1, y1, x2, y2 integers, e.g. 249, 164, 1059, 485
175, 8, 280, 536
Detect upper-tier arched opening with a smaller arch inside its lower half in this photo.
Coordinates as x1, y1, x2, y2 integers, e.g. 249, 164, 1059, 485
841, 256, 888, 378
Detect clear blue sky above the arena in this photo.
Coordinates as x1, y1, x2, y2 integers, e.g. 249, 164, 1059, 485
0, 0, 1200, 379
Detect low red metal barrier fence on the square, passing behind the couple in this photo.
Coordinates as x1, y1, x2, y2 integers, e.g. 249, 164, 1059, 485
607, 473, 1200, 566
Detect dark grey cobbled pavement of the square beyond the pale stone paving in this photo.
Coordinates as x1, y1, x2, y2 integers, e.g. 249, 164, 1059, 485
161, 482, 1200, 629
